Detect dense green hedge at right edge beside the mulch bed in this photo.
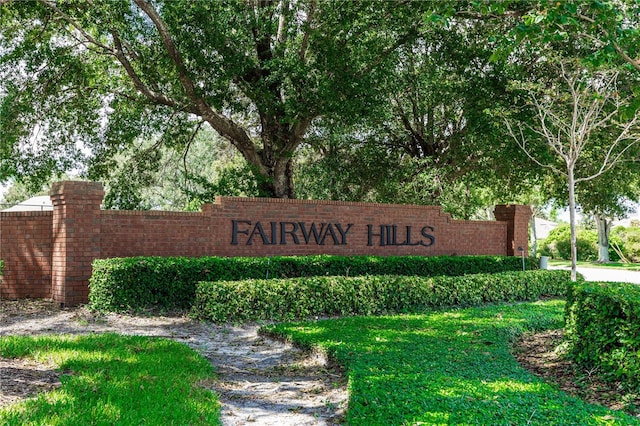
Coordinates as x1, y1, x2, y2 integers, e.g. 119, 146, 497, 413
565, 282, 640, 390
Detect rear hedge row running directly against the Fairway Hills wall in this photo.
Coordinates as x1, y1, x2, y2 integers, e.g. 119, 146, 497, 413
89, 255, 538, 312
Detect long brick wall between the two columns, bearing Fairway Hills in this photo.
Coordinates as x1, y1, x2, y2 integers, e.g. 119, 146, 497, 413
100, 197, 508, 258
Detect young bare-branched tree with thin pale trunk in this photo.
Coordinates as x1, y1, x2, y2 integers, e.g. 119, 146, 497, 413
505, 61, 640, 280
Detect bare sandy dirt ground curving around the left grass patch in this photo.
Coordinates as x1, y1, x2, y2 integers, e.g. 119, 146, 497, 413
0, 300, 347, 426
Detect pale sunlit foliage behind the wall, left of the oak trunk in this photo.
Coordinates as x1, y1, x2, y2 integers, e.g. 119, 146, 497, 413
99, 129, 263, 210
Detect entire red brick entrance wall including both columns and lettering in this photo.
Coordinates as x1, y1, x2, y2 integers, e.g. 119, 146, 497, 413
0, 181, 531, 306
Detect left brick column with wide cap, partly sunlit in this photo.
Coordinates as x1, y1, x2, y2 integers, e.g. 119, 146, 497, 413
49, 181, 104, 306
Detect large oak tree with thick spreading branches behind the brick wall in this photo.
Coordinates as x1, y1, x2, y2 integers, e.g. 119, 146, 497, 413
0, 0, 424, 198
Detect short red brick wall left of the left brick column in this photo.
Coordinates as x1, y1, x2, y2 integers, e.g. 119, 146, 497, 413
0, 211, 53, 299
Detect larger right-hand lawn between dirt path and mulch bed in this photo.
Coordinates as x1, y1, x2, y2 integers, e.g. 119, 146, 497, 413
264, 301, 640, 426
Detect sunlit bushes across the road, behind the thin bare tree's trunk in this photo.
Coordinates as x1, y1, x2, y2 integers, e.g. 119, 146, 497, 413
539, 224, 600, 261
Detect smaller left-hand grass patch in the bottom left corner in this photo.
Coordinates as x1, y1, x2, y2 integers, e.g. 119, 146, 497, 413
0, 334, 220, 426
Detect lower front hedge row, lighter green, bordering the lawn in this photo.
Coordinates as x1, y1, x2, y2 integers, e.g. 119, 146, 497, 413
191, 271, 571, 323
